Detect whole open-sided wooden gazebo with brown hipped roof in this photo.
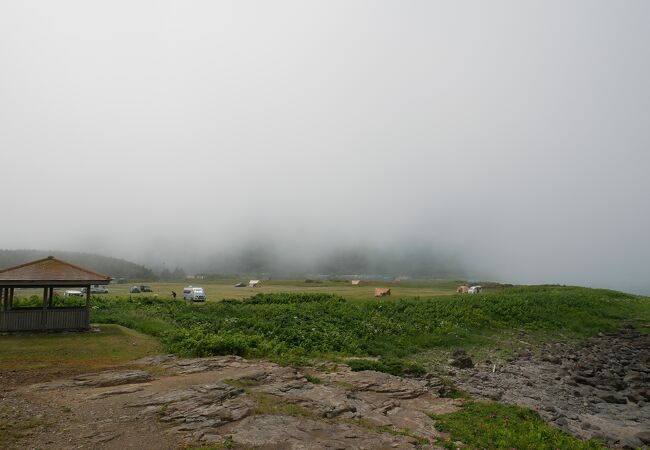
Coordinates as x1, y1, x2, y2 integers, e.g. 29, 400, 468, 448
0, 256, 111, 332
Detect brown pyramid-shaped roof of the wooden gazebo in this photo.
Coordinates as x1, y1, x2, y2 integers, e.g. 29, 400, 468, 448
0, 256, 111, 287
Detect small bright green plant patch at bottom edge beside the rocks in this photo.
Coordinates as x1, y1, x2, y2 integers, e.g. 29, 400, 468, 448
431, 401, 607, 450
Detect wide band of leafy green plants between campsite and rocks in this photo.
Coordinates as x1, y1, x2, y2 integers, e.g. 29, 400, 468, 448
92, 286, 650, 373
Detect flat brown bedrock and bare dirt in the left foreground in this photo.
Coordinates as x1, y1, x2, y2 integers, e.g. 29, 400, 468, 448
2, 356, 459, 449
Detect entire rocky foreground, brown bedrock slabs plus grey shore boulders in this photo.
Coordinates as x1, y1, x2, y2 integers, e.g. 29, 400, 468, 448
0, 328, 650, 450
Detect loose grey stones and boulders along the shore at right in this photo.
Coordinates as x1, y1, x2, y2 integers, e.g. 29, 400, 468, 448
449, 328, 650, 448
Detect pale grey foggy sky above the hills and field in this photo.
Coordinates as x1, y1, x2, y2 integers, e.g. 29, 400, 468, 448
0, 0, 650, 293
